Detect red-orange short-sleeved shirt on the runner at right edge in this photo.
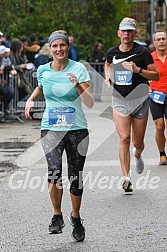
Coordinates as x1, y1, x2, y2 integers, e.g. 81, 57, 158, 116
150, 51, 167, 94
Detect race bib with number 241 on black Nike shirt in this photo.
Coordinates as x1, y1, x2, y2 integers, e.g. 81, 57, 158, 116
114, 71, 132, 85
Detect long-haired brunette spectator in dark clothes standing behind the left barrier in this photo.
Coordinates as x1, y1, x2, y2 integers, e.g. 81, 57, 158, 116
10, 38, 33, 100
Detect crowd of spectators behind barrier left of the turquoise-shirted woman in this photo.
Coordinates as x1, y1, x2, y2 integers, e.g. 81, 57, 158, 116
0, 31, 44, 116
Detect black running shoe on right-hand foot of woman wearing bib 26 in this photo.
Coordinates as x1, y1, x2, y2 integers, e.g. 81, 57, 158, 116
68, 213, 85, 242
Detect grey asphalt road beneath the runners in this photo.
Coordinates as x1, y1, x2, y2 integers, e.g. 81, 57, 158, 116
0, 103, 167, 252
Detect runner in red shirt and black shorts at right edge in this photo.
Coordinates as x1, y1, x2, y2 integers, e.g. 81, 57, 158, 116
150, 31, 167, 165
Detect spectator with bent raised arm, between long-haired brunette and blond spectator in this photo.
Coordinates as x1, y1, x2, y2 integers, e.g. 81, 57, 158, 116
24, 33, 40, 64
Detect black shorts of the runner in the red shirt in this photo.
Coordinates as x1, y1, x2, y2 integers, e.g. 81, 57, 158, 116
150, 97, 167, 120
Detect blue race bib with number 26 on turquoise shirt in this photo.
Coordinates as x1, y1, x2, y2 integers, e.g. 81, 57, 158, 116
49, 107, 75, 127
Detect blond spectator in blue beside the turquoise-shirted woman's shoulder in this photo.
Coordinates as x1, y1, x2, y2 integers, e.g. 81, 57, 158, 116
34, 43, 53, 68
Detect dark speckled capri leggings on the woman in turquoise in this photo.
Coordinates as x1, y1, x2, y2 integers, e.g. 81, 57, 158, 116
41, 129, 89, 196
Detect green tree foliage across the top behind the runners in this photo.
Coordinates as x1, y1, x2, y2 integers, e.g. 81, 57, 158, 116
0, 0, 128, 60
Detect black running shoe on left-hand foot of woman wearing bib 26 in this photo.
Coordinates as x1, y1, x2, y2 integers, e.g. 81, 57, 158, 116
49, 214, 65, 234
